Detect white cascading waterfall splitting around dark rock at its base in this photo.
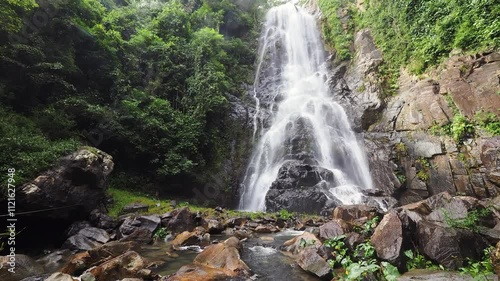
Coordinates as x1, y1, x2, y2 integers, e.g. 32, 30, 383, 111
239, 3, 372, 211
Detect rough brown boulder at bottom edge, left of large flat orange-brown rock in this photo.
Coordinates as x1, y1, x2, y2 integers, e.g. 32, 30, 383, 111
89, 251, 151, 281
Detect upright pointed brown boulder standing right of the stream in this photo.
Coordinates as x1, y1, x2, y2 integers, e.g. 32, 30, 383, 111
370, 212, 403, 264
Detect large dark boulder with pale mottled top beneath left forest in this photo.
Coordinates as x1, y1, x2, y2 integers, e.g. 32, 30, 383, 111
16, 147, 114, 219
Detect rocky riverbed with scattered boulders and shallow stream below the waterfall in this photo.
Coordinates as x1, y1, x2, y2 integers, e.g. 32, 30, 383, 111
0, 190, 500, 281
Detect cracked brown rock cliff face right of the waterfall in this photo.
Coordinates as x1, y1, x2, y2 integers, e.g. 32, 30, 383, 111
329, 29, 500, 204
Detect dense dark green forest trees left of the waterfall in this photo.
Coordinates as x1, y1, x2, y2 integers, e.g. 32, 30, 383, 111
0, 0, 258, 189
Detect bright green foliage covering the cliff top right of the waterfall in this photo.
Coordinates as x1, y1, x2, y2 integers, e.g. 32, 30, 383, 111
318, 0, 500, 97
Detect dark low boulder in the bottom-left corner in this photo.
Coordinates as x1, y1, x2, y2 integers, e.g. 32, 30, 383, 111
0, 254, 44, 281
